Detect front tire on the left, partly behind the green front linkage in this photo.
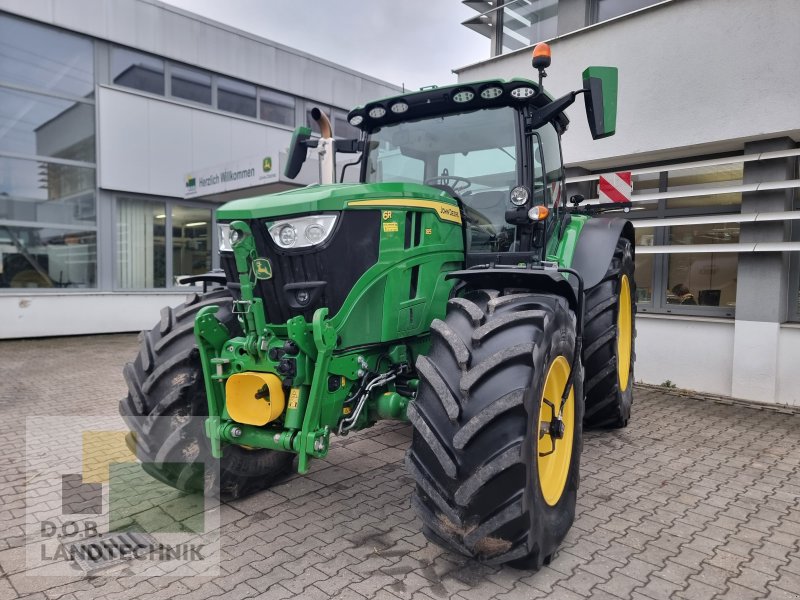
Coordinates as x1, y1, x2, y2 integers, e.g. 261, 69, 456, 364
119, 290, 293, 498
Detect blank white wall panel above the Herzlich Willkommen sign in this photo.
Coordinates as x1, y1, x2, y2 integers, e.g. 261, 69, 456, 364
97, 87, 292, 197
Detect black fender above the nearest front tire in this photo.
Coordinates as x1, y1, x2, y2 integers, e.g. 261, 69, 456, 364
445, 267, 580, 314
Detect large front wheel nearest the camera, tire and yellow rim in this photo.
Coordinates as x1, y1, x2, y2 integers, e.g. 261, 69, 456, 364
406, 290, 583, 569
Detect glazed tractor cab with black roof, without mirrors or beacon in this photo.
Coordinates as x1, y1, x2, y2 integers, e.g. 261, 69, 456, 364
350, 80, 566, 266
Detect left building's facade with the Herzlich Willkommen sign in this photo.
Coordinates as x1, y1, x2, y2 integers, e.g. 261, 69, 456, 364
0, 0, 399, 338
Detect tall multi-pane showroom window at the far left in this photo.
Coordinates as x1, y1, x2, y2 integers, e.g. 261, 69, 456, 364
0, 15, 97, 288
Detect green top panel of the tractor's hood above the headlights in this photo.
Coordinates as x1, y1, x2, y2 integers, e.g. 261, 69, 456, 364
217, 183, 457, 221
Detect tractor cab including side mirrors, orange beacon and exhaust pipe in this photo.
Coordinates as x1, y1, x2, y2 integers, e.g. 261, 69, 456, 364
285, 44, 617, 268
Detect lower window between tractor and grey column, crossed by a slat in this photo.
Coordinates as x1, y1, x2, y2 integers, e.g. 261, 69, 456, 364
665, 223, 739, 308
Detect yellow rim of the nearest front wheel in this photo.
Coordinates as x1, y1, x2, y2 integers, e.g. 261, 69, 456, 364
536, 356, 575, 506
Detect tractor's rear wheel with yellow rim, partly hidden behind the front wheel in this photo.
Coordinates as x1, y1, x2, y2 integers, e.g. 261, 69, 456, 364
583, 238, 636, 429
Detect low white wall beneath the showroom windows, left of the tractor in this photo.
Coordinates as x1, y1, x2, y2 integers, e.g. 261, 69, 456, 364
0, 291, 189, 339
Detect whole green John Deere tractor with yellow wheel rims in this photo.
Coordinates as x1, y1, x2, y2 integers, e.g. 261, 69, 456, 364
120, 45, 635, 568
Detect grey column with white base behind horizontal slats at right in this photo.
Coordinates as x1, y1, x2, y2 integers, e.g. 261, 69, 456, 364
731, 138, 795, 402
